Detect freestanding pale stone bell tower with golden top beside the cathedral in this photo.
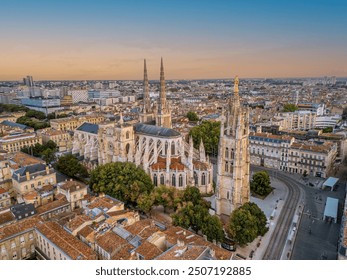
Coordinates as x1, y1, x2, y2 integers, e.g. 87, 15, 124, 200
216, 77, 250, 221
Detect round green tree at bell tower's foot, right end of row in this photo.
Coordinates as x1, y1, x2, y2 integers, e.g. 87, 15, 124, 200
228, 202, 268, 246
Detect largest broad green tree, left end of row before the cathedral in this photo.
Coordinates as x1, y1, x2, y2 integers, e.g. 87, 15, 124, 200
90, 162, 154, 206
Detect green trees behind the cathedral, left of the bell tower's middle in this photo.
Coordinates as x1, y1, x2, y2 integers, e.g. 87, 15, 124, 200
189, 121, 220, 155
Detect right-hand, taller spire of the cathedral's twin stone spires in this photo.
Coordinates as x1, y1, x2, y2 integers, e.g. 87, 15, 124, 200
156, 58, 171, 128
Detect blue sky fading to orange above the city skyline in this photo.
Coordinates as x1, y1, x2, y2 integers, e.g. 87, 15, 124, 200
0, 0, 347, 80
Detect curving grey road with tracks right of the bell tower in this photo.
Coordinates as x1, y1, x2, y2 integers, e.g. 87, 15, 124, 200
252, 166, 302, 260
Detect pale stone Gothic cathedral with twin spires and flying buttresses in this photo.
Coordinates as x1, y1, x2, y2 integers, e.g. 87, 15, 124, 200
72, 59, 213, 193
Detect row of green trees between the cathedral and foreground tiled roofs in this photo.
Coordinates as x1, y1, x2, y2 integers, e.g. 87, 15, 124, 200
90, 162, 267, 245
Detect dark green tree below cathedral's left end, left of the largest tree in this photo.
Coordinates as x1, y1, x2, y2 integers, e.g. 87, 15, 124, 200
55, 155, 88, 179
